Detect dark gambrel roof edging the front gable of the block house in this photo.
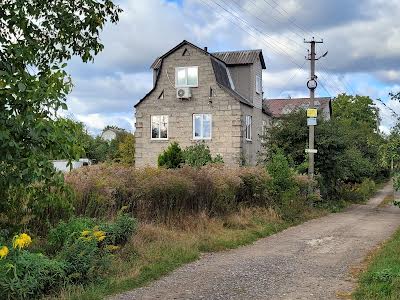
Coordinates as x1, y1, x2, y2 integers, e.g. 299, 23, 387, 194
134, 40, 261, 108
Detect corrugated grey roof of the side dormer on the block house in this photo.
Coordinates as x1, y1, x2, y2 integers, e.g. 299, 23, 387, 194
212, 49, 266, 69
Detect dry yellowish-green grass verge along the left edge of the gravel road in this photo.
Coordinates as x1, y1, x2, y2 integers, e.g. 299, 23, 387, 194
53, 208, 327, 299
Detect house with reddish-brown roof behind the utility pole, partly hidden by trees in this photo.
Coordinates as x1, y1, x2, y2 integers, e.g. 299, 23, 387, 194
264, 97, 332, 120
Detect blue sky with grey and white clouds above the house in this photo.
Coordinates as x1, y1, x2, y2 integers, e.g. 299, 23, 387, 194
67, 0, 400, 135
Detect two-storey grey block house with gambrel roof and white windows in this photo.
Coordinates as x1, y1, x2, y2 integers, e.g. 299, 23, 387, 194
135, 41, 271, 167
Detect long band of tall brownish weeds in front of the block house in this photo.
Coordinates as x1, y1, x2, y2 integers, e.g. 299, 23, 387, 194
66, 164, 316, 223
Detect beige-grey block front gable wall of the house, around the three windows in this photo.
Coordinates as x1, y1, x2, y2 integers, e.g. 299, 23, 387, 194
135, 45, 242, 167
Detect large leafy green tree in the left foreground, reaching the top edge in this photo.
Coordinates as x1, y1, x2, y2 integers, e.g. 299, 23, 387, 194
0, 0, 121, 232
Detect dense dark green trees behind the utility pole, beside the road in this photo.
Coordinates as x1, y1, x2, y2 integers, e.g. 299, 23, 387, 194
265, 94, 387, 198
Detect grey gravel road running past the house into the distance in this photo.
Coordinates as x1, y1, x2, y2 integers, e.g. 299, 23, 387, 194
112, 185, 400, 300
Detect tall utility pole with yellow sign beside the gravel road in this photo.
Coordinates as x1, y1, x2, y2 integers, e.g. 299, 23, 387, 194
304, 37, 328, 185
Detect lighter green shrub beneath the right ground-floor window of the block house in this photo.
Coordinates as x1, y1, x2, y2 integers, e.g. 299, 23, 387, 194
183, 142, 224, 167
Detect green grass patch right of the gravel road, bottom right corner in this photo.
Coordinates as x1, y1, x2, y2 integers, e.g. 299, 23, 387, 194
353, 230, 400, 300
